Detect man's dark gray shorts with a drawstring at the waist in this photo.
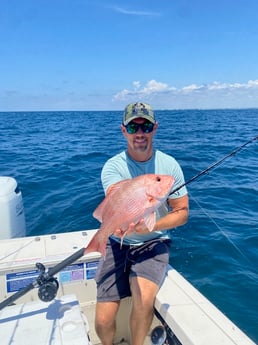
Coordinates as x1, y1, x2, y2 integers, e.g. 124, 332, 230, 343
95, 238, 171, 302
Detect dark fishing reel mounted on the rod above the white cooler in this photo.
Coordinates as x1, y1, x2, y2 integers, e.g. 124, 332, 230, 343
36, 262, 59, 302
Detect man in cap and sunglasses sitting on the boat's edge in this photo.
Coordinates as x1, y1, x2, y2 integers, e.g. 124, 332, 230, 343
95, 102, 188, 345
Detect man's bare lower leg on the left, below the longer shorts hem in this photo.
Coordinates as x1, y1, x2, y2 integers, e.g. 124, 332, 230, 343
95, 301, 120, 345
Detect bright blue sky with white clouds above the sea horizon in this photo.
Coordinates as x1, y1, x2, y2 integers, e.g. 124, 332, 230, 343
0, 0, 258, 111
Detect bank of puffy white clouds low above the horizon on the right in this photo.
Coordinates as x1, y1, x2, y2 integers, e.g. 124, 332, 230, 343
113, 79, 258, 108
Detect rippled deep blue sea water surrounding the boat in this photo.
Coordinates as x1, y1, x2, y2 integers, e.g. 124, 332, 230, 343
0, 109, 258, 342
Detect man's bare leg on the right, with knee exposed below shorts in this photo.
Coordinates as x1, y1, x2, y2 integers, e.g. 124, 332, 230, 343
130, 277, 159, 345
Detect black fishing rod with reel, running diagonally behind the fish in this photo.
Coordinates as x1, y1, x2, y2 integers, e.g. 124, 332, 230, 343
0, 136, 258, 310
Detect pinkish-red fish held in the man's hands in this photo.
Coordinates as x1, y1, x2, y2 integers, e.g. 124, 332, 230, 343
84, 174, 175, 257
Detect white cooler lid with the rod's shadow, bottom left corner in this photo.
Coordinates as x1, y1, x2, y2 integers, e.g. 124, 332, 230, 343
0, 295, 91, 345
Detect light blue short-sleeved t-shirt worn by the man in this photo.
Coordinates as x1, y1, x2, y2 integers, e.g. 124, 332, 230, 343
101, 150, 187, 245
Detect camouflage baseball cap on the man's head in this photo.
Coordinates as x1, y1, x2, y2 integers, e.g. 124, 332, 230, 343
123, 102, 156, 126
